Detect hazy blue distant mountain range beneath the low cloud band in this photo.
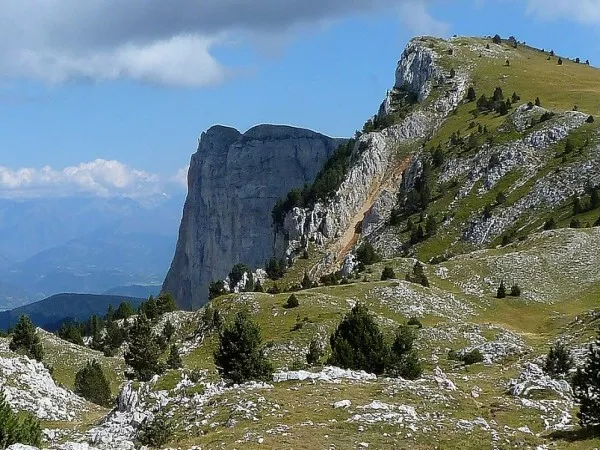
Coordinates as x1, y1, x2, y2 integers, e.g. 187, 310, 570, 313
0, 196, 184, 310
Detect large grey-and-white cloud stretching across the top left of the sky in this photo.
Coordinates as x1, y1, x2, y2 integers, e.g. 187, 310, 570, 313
0, 0, 440, 86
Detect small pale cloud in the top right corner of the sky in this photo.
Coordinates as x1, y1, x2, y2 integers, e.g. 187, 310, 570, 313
527, 0, 600, 25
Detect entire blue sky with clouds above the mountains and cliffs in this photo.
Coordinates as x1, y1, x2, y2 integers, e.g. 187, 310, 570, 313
0, 0, 600, 198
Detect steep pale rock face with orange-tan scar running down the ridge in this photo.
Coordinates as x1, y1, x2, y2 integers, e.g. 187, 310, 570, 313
275, 38, 468, 269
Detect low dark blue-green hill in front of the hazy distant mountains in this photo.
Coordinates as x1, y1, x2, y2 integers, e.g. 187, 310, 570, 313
0, 294, 144, 331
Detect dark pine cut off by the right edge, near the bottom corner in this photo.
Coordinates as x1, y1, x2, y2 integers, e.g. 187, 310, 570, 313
573, 334, 600, 427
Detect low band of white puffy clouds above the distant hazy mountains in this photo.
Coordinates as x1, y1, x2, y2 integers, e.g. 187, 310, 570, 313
0, 159, 188, 198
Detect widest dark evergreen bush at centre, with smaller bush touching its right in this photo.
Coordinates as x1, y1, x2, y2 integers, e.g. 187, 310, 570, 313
328, 304, 389, 374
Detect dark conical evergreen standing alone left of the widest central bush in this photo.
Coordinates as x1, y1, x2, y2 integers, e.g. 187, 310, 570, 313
214, 311, 273, 383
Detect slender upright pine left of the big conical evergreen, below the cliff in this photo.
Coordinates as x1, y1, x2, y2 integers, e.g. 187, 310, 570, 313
125, 314, 162, 381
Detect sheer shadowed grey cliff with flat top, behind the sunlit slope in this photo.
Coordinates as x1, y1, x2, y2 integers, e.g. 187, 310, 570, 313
163, 125, 343, 309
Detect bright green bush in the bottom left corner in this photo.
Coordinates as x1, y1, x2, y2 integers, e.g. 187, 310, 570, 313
0, 391, 42, 448
